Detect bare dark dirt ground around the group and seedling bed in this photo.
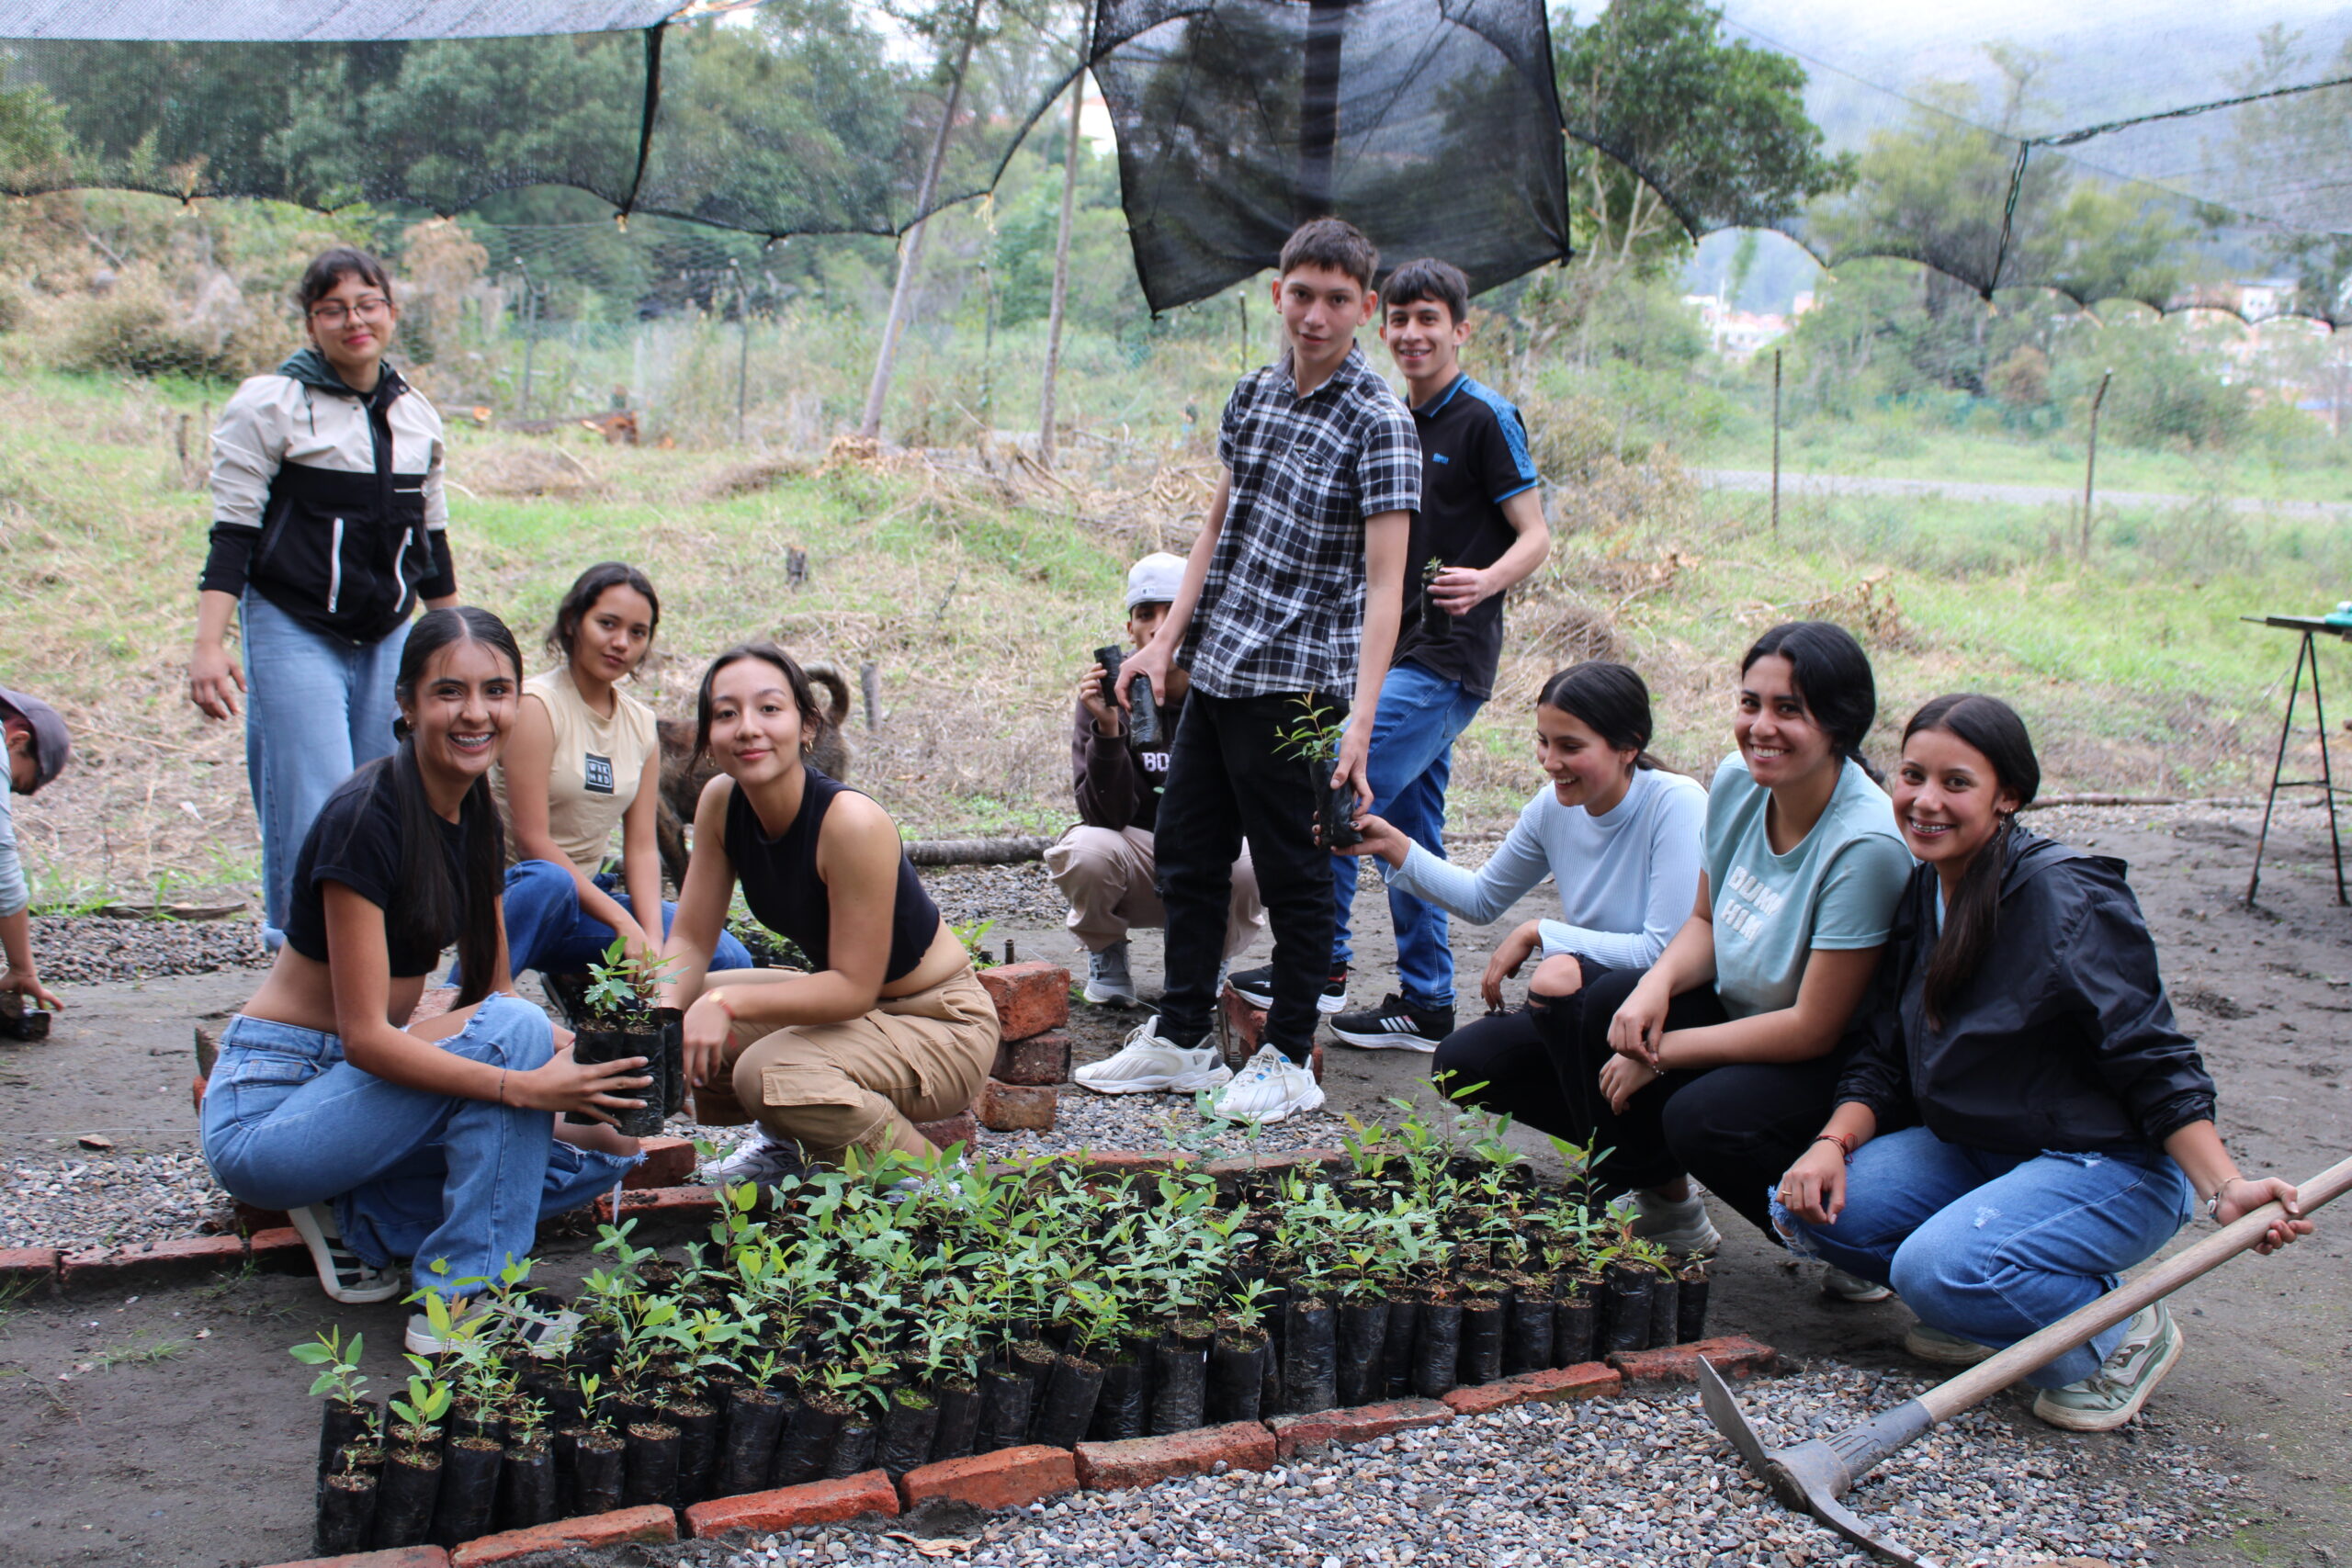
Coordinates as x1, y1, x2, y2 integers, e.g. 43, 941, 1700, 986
0, 808, 2352, 1568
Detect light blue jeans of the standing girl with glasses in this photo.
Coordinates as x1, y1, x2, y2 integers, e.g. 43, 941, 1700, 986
238, 590, 409, 950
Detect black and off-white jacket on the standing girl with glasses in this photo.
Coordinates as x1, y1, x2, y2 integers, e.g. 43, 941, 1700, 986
198, 348, 457, 644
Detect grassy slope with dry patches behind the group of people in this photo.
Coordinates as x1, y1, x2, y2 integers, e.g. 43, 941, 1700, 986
0, 367, 2352, 903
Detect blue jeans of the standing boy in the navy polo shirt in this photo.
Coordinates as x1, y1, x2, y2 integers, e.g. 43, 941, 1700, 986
1331, 665, 1484, 1006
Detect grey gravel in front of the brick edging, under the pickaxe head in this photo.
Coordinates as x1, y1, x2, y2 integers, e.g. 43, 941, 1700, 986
703, 1363, 2242, 1568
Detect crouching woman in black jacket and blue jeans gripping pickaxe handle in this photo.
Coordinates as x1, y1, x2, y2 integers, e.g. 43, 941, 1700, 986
1773, 694, 2312, 1432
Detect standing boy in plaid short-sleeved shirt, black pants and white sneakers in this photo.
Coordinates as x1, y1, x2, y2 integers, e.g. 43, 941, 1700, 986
1075, 219, 1420, 1122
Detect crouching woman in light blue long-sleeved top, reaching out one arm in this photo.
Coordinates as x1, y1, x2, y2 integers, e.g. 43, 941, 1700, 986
1348, 663, 1708, 1138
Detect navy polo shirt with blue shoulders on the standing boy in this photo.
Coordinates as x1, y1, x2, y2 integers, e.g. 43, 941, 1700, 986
1393, 376, 1536, 701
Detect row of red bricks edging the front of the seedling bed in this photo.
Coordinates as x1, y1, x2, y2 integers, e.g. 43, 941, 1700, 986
257, 1344, 1778, 1568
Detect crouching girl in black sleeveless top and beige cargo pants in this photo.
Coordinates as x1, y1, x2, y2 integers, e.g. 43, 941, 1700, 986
663, 642, 997, 1180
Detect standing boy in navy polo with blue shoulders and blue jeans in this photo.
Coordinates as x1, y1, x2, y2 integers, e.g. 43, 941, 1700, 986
1232, 259, 1553, 1051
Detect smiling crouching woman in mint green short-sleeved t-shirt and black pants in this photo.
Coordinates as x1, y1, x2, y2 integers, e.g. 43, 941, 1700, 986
1576, 621, 1912, 1259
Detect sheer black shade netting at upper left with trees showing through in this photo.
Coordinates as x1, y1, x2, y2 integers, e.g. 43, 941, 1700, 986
0, 0, 1084, 235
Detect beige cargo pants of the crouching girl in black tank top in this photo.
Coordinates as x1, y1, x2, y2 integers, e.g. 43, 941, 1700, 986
727, 966, 1000, 1164
